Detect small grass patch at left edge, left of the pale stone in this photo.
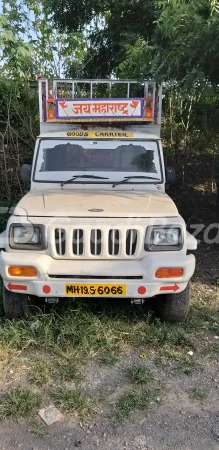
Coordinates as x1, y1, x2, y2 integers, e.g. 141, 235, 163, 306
0, 388, 42, 420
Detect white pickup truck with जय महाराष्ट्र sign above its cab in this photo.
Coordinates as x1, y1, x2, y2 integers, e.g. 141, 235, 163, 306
0, 79, 197, 321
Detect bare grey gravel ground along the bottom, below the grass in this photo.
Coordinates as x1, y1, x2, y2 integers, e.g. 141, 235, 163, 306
0, 364, 219, 450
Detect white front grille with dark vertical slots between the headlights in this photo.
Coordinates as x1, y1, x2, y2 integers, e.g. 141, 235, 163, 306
51, 227, 141, 259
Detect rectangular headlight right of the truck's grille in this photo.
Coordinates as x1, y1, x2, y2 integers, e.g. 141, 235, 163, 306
145, 226, 183, 251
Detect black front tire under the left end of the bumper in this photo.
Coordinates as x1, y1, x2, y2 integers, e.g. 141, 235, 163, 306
3, 286, 33, 319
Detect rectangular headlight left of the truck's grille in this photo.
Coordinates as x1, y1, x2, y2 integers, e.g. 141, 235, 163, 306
10, 224, 45, 250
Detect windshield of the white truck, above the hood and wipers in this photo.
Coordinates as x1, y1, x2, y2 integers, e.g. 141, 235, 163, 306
35, 139, 162, 183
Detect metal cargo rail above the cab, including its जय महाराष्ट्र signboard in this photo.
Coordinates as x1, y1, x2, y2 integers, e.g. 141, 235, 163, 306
39, 78, 162, 135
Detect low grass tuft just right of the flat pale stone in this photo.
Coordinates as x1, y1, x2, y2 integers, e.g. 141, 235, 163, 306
52, 387, 97, 420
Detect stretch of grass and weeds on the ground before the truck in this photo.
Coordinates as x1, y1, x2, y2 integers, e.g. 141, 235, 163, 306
0, 268, 219, 433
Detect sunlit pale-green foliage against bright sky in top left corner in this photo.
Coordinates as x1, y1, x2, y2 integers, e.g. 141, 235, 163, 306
0, 0, 86, 81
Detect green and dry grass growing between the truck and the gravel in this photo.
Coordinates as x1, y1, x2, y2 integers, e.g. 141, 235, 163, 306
0, 282, 219, 422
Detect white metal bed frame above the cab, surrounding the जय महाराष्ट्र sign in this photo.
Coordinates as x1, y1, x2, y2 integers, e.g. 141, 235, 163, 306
38, 78, 162, 136
